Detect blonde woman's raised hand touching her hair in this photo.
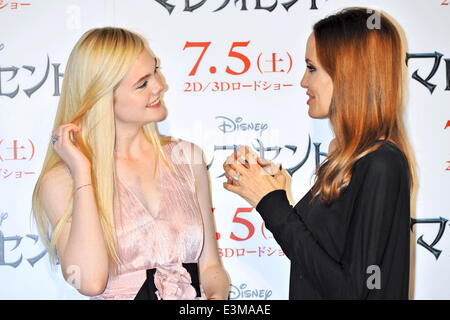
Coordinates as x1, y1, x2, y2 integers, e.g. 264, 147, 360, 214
52, 123, 91, 176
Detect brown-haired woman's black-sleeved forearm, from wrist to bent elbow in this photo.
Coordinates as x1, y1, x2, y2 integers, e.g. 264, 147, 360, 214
256, 190, 370, 299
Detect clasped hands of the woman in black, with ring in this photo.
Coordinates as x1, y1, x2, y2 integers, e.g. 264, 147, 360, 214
223, 146, 286, 207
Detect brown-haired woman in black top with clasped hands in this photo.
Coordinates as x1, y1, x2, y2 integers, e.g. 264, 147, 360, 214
224, 8, 415, 299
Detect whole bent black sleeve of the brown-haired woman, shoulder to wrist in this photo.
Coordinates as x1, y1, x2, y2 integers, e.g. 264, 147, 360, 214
256, 159, 409, 299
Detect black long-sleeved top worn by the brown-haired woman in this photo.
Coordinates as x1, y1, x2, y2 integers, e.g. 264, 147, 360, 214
256, 142, 410, 299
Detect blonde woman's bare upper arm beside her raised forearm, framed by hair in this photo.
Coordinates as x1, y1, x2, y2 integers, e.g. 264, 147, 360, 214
39, 164, 73, 227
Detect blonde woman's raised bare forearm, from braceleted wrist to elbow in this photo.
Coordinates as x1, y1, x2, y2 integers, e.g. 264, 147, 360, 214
60, 173, 109, 295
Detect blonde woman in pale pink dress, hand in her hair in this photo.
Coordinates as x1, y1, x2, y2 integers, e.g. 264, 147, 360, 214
33, 27, 229, 299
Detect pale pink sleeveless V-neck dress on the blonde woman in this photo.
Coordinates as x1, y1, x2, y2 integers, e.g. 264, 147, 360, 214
91, 141, 205, 300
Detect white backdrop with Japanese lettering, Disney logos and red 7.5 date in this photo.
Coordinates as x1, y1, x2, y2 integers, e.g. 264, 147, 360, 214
0, 0, 450, 299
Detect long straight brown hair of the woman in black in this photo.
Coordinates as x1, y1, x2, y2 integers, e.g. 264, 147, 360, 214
312, 8, 415, 204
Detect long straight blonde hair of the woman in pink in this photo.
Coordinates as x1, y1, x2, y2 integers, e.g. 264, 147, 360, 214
32, 27, 167, 266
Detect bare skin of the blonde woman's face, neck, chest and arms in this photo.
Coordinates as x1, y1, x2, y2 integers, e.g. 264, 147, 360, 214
41, 50, 229, 299
